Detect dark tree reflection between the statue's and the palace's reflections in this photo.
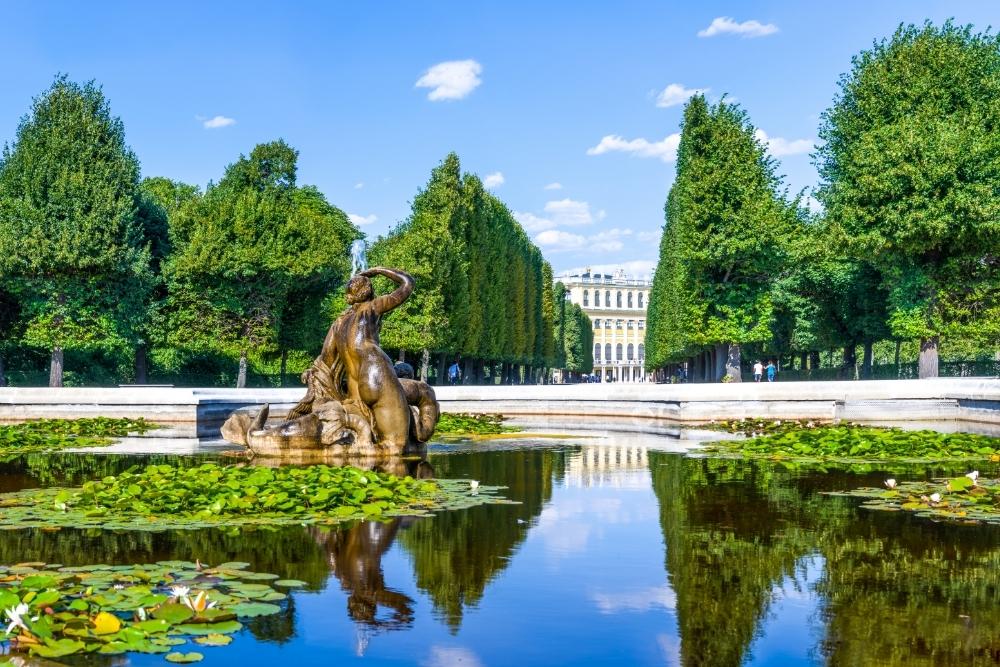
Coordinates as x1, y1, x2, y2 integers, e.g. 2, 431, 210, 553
400, 449, 566, 632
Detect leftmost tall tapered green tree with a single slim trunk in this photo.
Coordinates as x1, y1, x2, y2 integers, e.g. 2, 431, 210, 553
0, 76, 152, 386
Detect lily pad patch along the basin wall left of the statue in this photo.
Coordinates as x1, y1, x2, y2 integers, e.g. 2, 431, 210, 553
0, 417, 157, 455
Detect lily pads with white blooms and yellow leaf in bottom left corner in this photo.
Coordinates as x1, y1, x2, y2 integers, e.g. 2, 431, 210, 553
0, 561, 292, 662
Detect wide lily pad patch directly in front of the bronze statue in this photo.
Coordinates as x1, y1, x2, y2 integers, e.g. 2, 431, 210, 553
0, 463, 506, 530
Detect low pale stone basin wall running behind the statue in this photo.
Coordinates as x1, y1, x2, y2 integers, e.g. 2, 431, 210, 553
0, 378, 1000, 438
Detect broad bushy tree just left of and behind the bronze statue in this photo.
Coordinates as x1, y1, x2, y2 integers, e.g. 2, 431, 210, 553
163, 140, 359, 387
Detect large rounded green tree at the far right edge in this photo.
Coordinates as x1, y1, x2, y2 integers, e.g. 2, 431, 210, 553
816, 22, 1000, 377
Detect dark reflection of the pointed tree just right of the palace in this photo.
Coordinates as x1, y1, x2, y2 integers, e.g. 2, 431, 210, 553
649, 452, 809, 667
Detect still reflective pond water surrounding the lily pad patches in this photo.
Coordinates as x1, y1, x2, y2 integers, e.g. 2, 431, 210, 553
0, 441, 1000, 667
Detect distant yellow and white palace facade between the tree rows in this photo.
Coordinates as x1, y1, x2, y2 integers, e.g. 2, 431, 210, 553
559, 269, 652, 382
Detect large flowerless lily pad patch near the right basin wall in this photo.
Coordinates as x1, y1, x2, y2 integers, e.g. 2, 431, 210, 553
702, 425, 1000, 463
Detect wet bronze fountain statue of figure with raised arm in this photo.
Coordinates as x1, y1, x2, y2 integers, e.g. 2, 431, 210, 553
222, 267, 440, 456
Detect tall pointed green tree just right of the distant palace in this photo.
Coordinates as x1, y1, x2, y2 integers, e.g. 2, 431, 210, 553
647, 95, 794, 381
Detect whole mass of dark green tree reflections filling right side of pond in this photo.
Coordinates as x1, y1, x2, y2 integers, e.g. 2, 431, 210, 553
650, 453, 1000, 666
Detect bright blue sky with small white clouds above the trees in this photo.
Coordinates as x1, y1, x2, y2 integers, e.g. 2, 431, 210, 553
0, 0, 1000, 275
